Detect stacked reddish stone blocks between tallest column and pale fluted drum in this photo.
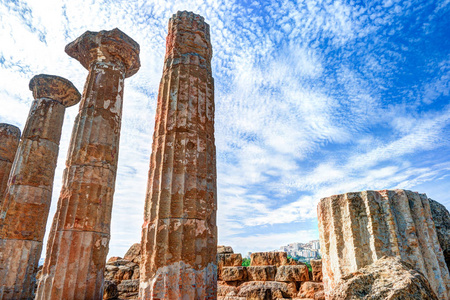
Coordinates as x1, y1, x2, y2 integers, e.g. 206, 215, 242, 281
217, 252, 324, 300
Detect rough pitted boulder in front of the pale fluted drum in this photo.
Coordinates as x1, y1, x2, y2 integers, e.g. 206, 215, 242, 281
327, 257, 438, 300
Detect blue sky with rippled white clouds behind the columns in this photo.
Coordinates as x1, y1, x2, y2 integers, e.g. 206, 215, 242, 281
0, 0, 450, 256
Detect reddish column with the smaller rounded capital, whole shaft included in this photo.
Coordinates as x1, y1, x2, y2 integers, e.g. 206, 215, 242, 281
0, 75, 81, 299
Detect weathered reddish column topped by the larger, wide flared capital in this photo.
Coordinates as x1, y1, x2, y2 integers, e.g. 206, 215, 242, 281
36, 28, 140, 300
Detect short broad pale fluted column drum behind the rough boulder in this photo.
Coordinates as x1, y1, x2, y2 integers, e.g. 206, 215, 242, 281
317, 190, 450, 299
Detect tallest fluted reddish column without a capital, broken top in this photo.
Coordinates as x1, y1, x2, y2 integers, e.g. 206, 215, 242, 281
139, 11, 217, 299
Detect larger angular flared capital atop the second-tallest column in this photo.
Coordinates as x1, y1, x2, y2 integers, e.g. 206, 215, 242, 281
65, 28, 141, 77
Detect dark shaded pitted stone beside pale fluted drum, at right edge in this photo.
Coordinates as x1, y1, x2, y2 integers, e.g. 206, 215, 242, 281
429, 199, 450, 270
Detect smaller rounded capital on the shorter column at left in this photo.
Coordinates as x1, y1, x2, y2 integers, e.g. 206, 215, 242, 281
29, 74, 81, 107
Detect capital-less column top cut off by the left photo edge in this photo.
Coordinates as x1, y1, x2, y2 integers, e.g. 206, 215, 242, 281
0, 123, 20, 208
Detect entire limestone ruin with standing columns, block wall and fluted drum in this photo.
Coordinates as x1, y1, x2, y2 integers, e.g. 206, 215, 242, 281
0, 11, 450, 300
